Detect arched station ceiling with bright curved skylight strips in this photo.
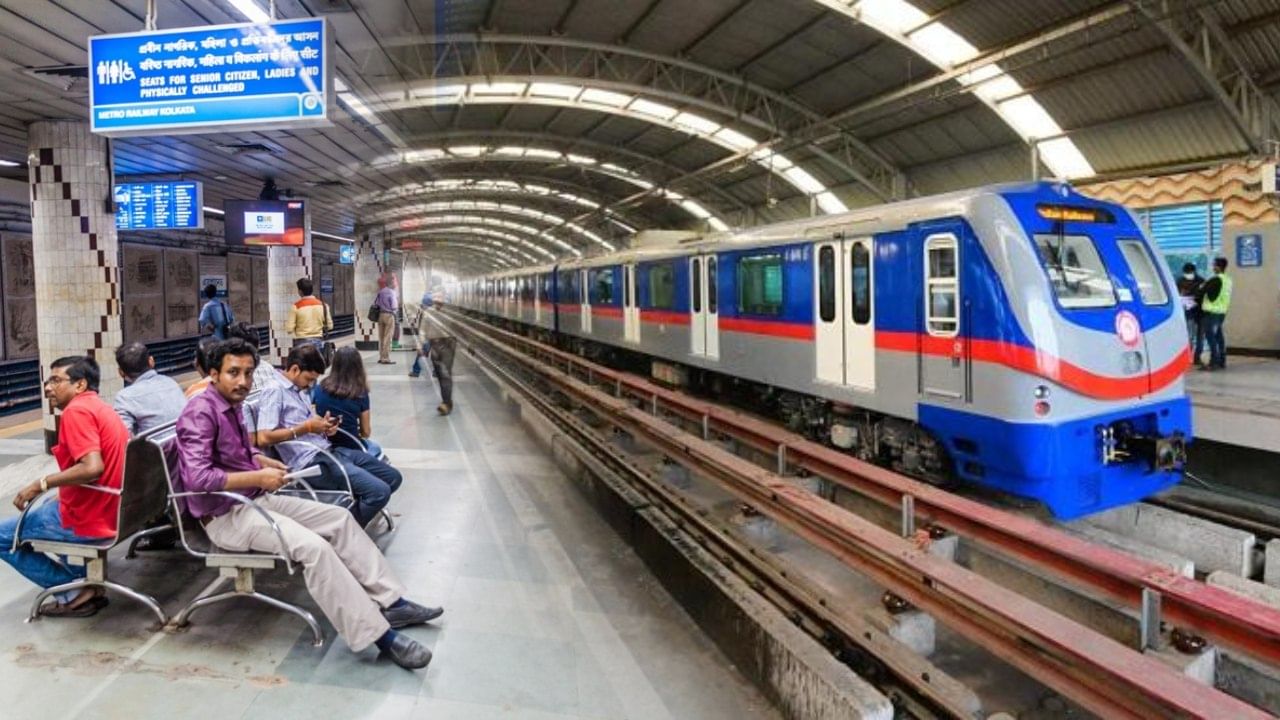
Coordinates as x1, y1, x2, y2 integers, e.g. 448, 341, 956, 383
0, 0, 1280, 273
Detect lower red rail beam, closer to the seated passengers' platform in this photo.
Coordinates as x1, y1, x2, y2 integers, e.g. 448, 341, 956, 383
437, 310, 1270, 719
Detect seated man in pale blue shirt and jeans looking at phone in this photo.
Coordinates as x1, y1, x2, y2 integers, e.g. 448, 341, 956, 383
257, 345, 403, 525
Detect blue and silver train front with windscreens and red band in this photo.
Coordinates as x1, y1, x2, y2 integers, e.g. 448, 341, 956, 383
962, 183, 1192, 518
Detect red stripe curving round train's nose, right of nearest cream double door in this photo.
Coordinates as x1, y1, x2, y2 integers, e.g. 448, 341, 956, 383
876, 332, 1192, 400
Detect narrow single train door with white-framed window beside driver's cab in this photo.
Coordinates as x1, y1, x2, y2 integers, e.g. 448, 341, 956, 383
918, 227, 968, 400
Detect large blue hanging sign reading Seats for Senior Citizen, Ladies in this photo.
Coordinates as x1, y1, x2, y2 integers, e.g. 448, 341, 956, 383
88, 18, 333, 136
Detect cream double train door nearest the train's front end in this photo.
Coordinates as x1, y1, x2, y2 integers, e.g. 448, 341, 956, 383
814, 236, 876, 389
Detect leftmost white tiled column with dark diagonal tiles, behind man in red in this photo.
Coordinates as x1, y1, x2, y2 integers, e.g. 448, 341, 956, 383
27, 120, 123, 445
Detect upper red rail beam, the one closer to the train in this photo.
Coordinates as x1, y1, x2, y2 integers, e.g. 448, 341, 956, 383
437, 307, 1280, 666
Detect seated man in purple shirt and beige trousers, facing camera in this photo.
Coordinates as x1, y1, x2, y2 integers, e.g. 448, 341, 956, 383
178, 338, 444, 669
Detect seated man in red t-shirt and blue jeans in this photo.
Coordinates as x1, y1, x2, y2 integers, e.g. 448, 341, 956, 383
0, 356, 129, 618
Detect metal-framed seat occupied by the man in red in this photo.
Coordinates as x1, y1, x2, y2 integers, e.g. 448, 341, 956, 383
12, 438, 169, 625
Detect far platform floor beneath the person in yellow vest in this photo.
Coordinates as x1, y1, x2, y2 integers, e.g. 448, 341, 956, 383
1187, 355, 1280, 452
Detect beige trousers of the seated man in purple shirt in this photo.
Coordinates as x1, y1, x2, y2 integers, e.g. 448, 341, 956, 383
205, 495, 404, 652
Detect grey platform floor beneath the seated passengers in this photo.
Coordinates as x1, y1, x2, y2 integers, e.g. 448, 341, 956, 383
0, 354, 778, 720
